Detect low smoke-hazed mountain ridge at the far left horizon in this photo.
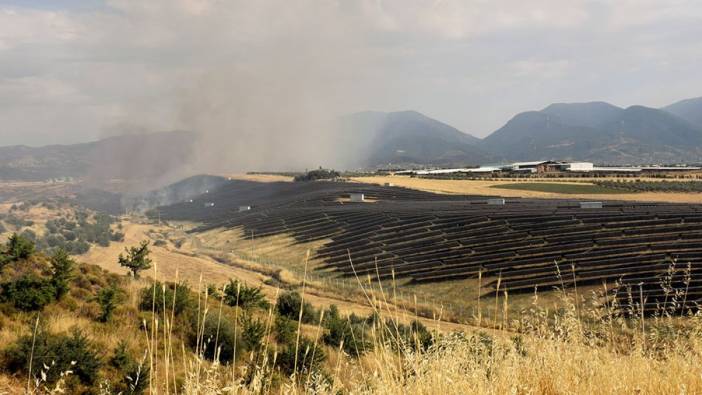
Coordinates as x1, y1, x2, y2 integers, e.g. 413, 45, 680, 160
0, 132, 193, 181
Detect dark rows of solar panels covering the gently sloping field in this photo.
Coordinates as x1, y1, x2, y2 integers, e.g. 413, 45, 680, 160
157, 181, 702, 310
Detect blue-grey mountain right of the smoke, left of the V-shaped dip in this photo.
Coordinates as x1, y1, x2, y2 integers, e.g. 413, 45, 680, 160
337, 111, 494, 168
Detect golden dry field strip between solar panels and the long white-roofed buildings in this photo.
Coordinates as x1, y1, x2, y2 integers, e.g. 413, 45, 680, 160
352, 176, 702, 203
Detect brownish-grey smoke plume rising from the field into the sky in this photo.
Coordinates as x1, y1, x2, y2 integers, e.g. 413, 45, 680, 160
156, 1, 382, 172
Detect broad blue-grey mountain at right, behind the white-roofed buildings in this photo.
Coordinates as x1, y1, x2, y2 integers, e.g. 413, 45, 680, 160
480, 102, 702, 164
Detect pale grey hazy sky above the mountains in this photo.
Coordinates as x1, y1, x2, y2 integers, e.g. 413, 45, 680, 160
0, 0, 702, 145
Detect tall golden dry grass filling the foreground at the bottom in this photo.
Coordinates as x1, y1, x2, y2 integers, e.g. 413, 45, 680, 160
17, 252, 702, 395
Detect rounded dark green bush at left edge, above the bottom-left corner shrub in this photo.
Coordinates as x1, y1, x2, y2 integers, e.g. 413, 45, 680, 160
0, 275, 56, 311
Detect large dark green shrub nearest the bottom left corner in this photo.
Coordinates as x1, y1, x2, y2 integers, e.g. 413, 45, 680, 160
3, 330, 101, 384
